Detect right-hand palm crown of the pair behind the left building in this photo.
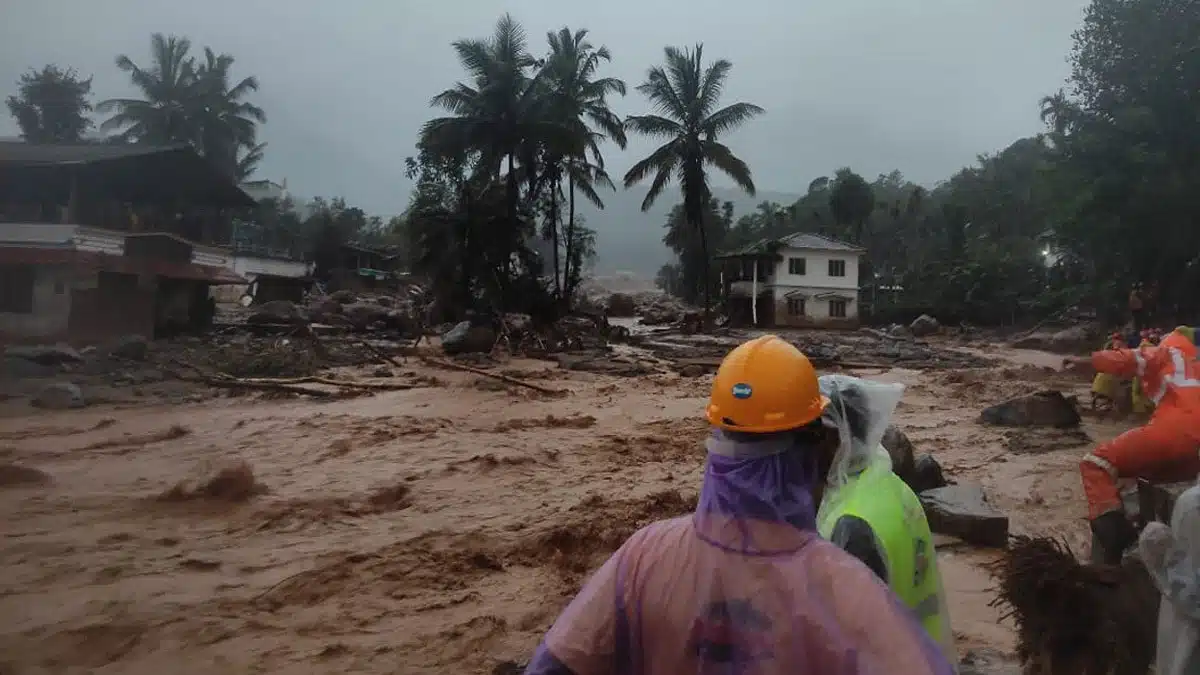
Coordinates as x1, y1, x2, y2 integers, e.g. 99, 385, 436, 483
192, 47, 266, 177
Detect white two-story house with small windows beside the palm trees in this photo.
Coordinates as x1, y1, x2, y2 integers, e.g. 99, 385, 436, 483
719, 232, 865, 327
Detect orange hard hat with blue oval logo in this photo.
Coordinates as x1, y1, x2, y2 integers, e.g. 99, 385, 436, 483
707, 335, 829, 434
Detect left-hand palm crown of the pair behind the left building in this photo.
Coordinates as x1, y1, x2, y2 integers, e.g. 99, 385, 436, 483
96, 32, 198, 143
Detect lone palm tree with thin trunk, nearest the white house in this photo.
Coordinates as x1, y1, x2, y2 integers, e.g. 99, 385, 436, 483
625, 44, 764, 324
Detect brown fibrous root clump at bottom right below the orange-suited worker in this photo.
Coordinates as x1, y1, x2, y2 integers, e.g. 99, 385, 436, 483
994, 537, 1159, 675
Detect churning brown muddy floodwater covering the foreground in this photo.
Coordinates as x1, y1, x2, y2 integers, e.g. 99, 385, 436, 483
0, 333, 1137, 675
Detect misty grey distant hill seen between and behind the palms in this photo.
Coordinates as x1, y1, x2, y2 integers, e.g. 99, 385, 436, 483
578, 186, 802, 280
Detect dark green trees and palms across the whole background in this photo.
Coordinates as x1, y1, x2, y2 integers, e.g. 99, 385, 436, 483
8, 0, 1200, 323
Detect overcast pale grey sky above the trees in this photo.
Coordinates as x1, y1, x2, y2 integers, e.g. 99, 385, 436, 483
0, 0, 1086, 214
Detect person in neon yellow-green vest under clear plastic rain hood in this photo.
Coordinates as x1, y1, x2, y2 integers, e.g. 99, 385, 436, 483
817, 375, 955, 663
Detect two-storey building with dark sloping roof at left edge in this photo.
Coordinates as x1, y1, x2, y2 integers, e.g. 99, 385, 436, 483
0, 142, 254, 344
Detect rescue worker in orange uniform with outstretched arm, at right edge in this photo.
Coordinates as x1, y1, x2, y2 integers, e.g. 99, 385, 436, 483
1068, 325, 1200, 565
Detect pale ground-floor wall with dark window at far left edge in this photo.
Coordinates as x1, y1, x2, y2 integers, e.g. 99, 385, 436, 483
0, 264, 73, 341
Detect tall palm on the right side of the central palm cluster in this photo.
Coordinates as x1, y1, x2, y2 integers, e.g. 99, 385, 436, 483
542, 26, 626, 304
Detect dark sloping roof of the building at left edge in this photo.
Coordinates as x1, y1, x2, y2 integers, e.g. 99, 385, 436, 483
0, 142, 257, 208
